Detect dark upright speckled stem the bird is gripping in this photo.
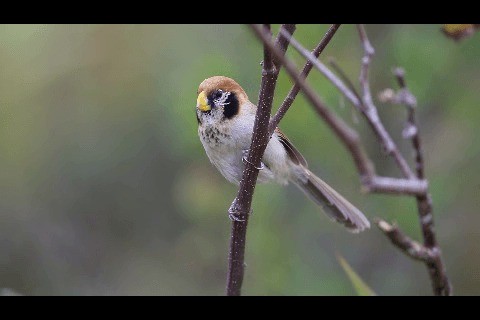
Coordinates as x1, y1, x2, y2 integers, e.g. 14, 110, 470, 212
226, 25, 288, 296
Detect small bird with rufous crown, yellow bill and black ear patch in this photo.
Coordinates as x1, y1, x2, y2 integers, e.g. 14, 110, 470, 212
196, 76, 370, 233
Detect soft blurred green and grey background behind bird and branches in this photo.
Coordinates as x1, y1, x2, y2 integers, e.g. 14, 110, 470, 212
0, 25, 480, 295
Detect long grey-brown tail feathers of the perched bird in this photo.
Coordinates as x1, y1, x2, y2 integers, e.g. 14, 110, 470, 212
295, 168, 370, 233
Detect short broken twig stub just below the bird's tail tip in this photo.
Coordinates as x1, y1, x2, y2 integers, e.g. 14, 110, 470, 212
375, 219, 435, 262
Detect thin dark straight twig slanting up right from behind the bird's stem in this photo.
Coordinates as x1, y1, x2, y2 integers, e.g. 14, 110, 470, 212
268, 24, 340, 136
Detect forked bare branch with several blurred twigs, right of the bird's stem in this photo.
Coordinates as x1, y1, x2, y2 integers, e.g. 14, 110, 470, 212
270, 25, 451, 295
